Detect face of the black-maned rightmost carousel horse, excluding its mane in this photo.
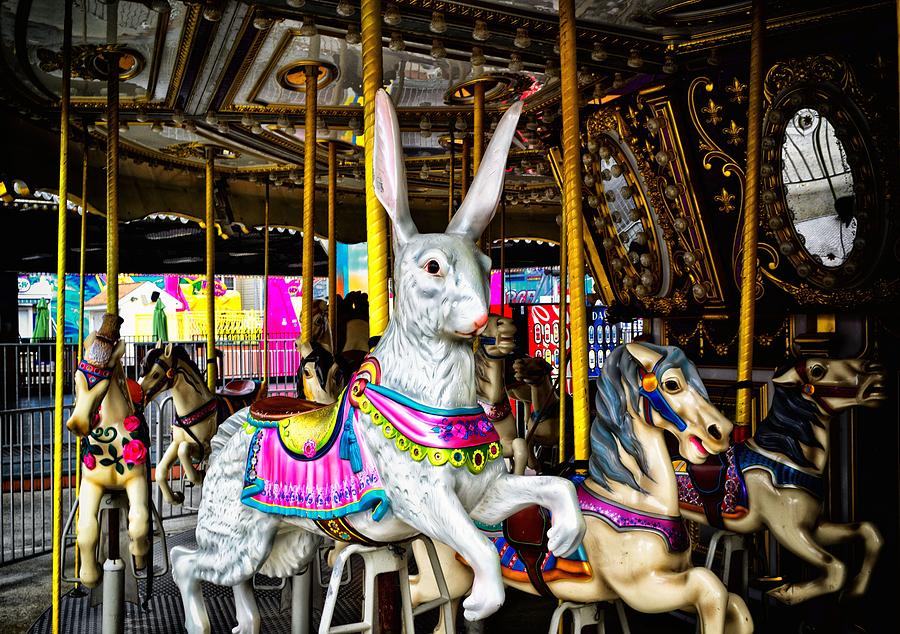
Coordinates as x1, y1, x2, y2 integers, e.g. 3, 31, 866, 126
772, 357, 887, 415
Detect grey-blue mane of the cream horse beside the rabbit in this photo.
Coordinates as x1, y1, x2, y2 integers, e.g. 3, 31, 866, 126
589, 342, 709, 493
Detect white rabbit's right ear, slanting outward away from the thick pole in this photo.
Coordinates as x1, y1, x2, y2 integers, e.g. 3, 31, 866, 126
446, 101, 522, 240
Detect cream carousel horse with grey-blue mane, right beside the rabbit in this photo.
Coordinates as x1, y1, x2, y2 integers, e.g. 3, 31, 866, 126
411, 343, 753, 634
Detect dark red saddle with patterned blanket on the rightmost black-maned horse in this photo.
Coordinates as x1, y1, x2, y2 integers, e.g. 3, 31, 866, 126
672, 445, 750, 528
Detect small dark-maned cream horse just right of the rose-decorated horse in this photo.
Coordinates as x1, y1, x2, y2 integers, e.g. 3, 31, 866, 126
140, 342, 259, 505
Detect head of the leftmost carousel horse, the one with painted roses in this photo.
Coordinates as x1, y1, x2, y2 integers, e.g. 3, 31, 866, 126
66, 314, 125, 436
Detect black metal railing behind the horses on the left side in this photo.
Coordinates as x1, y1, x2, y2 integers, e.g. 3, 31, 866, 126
0, 336, 299, 566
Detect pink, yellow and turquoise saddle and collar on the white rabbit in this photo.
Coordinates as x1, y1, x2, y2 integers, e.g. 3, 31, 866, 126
241, 357, 501, 534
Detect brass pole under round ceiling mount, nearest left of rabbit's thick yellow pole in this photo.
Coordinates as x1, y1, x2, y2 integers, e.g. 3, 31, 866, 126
300, 66, 318, 341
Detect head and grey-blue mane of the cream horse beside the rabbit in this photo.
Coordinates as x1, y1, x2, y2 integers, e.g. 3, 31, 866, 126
591, 343, 732, 490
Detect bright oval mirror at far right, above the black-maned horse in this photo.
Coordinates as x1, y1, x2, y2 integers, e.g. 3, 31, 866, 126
781, 108, 857, 268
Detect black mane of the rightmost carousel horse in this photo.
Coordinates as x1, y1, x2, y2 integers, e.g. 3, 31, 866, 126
753, 364, 822, 467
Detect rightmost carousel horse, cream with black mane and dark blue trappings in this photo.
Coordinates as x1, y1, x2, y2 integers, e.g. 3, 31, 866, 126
674, 357, 887, 604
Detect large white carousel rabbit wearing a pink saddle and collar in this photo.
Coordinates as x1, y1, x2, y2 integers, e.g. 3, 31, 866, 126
171, 90, 584, 634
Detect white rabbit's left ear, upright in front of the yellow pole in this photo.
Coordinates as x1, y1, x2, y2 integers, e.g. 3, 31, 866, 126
372, 89, 419, 244
